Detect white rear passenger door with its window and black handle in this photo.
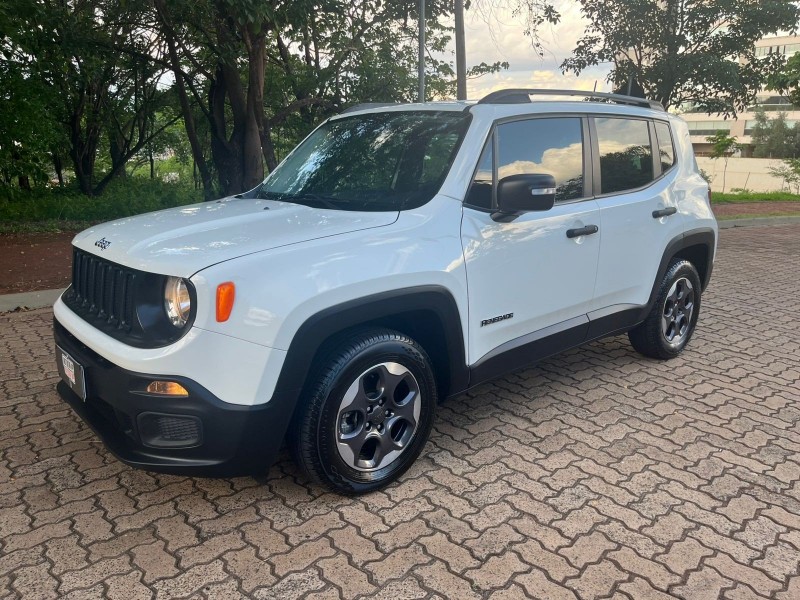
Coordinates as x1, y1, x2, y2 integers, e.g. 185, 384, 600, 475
589, 116, 683, 318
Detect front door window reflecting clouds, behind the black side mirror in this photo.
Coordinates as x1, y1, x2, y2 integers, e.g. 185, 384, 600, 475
497, 117, 583, 202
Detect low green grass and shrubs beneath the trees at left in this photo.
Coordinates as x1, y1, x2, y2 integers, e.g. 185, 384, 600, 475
0, 177, 203, 225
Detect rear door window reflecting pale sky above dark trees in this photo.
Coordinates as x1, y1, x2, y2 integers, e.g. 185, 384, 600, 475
595, 118, 653, 194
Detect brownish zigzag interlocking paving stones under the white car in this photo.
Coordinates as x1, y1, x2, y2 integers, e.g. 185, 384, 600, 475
0, 225, 800, 600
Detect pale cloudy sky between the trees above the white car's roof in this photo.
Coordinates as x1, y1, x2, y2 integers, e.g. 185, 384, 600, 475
444, 0, 611, 99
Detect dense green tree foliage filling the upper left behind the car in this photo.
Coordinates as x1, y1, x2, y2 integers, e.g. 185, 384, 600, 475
0, 0, 528, 206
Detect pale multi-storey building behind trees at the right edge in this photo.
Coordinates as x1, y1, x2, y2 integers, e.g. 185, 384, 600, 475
681, 36, 800, 156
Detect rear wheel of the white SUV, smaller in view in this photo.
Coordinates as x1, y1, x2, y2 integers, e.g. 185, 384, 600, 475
628, 260, 701, 360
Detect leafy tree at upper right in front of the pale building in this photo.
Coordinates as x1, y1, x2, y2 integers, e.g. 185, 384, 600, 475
561, 0, 800, 115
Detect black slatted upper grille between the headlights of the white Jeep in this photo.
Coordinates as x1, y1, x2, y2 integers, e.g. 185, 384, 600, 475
70, 248, 137, 333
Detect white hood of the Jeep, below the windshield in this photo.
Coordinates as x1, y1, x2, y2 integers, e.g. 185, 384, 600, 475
72, 198, 399, 277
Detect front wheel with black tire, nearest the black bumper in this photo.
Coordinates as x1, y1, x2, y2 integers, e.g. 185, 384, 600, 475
289, 329, 437, 496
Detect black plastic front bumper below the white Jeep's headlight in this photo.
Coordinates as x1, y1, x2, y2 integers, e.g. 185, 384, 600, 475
53, 320, 294, 477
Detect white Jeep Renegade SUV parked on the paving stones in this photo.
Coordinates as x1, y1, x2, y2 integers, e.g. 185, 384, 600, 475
54, 90, 717, 494
